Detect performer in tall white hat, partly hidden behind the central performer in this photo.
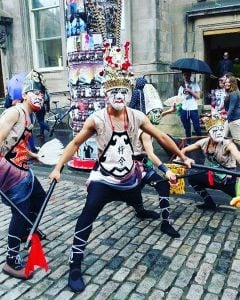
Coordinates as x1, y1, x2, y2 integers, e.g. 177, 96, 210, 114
129, 78, 180, 238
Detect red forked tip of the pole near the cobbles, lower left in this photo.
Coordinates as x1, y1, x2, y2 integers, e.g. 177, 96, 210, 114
25, 233, 48, 277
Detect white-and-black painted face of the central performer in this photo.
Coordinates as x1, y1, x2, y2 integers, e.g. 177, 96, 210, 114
107, 88, 129, 110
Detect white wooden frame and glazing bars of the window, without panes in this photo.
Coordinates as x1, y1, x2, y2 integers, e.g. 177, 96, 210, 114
29, 0, 66, 72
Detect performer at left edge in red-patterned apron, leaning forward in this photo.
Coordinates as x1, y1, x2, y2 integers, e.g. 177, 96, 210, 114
0, 71, 46, 279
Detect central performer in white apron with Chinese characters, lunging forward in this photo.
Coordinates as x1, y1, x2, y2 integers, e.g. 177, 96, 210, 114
49, 43, 193, 293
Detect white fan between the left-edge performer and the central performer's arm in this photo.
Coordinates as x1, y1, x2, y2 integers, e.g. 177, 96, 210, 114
38, 139, 64, 165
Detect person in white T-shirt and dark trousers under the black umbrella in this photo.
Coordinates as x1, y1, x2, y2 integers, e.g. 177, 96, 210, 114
178, 70, 201, 143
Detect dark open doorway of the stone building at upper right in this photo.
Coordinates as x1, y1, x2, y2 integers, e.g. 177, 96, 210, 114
204, 28, 240, 104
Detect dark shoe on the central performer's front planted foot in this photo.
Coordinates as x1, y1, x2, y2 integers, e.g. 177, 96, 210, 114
68, 264, 85, 293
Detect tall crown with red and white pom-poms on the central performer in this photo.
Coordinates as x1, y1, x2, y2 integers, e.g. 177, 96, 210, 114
100, 42, 134, 91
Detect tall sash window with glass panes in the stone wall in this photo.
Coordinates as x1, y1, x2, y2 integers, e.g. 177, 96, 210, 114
31, 0, 64, 70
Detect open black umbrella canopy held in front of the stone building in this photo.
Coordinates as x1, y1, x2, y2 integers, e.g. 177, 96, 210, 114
170, 58, 212, 74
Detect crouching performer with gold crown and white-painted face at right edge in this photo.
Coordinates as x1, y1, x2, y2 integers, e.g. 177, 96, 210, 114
181, 117, 240, 210
